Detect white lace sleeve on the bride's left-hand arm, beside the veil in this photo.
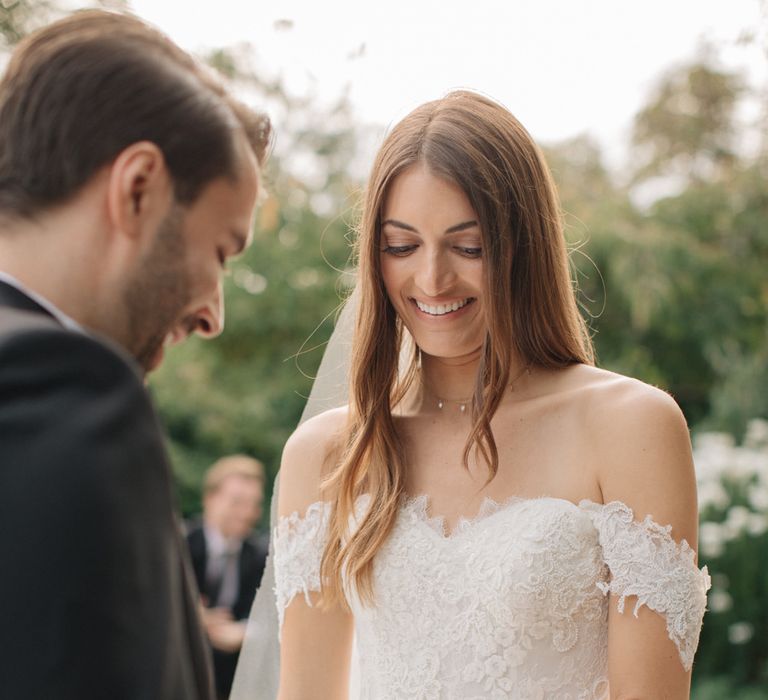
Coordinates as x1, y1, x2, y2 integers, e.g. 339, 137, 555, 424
274, 501, 330, 630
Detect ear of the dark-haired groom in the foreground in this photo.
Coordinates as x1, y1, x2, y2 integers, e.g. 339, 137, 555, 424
107, 141, 173, 241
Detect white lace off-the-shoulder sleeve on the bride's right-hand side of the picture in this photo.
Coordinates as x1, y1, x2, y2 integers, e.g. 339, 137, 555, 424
580, 501, 711, 671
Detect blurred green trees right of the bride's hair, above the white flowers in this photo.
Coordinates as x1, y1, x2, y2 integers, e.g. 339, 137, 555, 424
547, 64, 768, 435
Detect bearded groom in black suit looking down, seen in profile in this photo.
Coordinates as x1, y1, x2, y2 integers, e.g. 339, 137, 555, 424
0, 12, 269, 700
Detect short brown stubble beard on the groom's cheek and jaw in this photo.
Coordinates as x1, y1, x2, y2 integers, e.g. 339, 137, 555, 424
124, 206, 192, 372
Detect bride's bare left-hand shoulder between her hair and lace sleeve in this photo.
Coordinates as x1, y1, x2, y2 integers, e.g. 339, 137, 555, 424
278, 406, 348, 516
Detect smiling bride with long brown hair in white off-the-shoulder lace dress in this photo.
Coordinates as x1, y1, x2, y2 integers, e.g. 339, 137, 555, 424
232, 91, 709, 700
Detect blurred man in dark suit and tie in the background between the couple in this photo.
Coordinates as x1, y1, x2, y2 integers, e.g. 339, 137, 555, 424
187, 455, 267, 698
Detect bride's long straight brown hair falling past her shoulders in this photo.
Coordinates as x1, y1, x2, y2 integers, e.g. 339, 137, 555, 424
321, 91, 593, 606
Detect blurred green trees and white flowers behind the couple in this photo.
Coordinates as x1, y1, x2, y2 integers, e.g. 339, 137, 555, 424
0, 0, 768, 700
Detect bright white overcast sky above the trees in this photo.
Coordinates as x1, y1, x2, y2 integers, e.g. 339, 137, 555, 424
132, 0, 768, 163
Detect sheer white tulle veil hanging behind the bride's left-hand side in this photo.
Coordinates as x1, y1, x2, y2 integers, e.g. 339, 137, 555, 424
230, 284, 358, 700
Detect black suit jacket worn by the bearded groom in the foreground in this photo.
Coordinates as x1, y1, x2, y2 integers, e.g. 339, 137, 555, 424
0, 283, 213, 700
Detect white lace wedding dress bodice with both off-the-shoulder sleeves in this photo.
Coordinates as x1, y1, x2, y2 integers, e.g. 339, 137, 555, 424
274, 496, 710, 700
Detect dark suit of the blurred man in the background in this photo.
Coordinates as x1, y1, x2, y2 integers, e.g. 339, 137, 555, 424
187, 524, 267, 697
